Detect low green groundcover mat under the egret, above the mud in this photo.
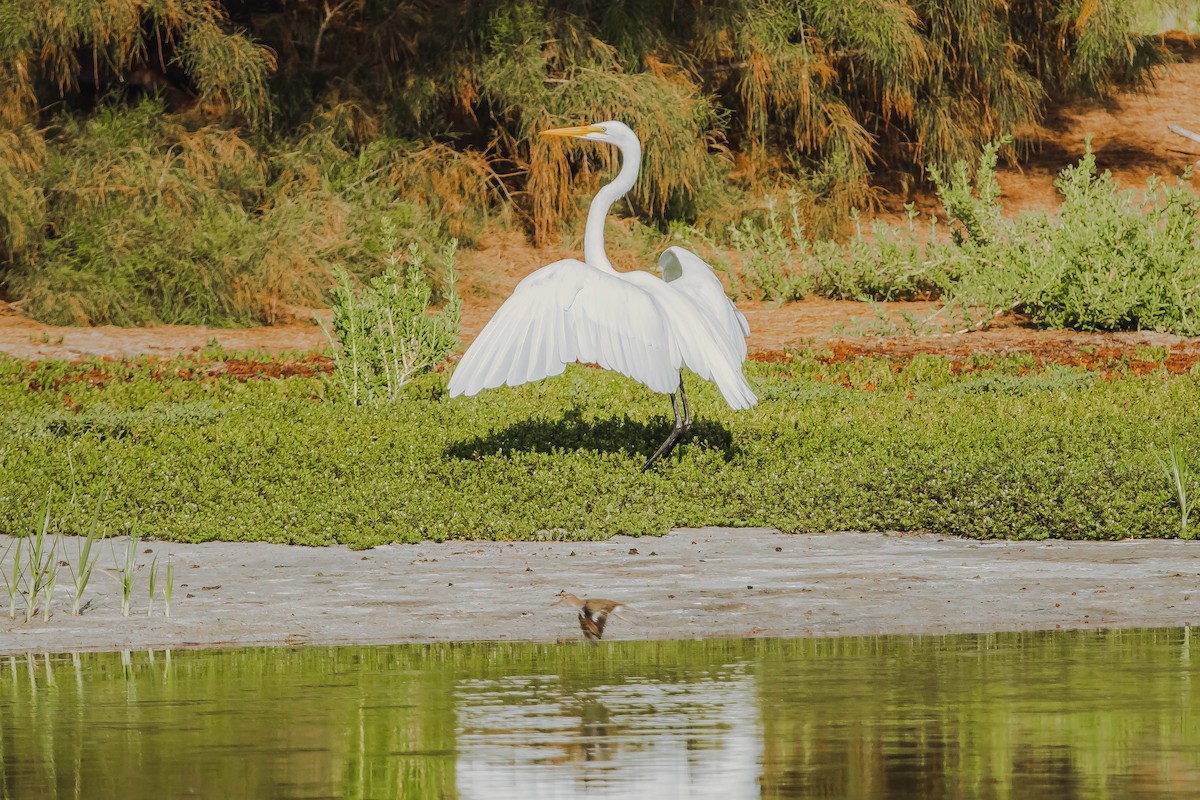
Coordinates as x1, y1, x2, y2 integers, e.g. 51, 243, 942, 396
0, 353, 1200, 547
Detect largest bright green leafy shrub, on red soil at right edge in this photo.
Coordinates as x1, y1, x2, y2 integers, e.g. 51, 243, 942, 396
946, 142, 1200, 335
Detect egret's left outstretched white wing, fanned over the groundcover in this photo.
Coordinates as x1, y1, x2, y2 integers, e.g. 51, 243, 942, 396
450, 259, 680, 397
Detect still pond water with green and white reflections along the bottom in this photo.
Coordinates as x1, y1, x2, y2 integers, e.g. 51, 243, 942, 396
0, 628, 1200, 800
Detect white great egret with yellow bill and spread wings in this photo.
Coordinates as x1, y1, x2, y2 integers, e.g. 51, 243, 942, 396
450, 121, 758, 473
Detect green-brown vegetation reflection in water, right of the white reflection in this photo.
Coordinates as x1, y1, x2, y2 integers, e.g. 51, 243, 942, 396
758, 630, 1200, 800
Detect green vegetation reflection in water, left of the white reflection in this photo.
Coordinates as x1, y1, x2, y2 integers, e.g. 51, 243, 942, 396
0, 648, 456, 799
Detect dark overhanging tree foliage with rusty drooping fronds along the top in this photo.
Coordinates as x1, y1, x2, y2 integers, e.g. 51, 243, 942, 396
0, 0, 1169, 236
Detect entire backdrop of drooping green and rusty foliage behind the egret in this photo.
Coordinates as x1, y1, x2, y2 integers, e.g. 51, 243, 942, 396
0, 0, 1170, 325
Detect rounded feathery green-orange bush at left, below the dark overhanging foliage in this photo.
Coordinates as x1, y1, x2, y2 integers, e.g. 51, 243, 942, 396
0, 100, 488, 325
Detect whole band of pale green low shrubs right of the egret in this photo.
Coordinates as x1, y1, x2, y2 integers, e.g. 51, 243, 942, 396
730, 142, 1200, 336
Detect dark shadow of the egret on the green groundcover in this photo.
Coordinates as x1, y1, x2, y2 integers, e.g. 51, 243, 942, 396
446, 409, 733, 461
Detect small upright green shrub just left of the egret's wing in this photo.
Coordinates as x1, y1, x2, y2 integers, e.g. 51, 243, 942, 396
325, 221, 462, 405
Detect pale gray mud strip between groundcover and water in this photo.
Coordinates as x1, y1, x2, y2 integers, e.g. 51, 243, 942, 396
0, 528, 1200, 654
